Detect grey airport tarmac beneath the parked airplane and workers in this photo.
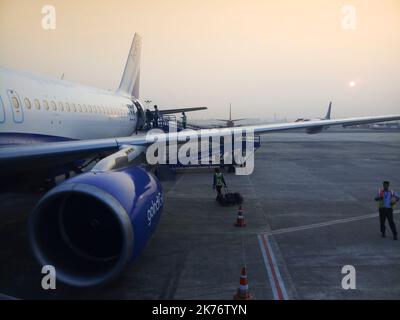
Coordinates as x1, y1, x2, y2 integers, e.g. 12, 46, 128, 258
0, 130, 400, 300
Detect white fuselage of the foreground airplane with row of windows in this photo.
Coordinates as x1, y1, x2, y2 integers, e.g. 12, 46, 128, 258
0, 67, 138, 145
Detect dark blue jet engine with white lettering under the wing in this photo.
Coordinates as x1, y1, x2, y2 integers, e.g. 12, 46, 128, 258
29, 167, 163, 287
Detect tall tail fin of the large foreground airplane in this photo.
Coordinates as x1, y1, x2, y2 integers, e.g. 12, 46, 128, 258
117, 33, 142, 98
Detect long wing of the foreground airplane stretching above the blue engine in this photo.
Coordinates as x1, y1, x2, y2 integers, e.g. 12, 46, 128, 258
0, 115, 400, 175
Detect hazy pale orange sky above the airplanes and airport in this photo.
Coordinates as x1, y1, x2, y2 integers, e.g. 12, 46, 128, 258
0, 0, 400, 118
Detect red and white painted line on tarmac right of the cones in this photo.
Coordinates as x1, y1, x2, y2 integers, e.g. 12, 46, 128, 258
258, 235, 289, 300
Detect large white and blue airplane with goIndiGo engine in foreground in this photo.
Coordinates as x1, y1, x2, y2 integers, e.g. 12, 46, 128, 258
0, 34, 400, 287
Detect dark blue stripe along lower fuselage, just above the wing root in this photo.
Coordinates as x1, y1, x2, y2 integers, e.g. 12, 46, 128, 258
0, 132, 74, 147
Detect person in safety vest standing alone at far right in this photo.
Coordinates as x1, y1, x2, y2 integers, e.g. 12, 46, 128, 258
375, 181, 399, 240
